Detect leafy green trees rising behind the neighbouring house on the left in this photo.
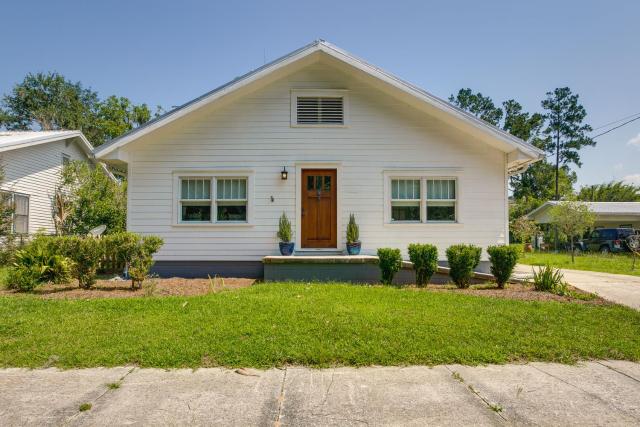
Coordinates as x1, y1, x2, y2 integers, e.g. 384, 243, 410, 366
0, 72, 161, 146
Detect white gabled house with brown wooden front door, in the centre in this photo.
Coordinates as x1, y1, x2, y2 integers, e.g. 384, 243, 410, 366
95, 41, 543, 275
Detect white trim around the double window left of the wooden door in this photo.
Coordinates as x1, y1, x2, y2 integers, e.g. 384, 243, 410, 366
172, 169, 255, 227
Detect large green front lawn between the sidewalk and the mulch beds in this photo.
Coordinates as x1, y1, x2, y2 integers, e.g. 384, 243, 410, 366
0, 283, 640, 368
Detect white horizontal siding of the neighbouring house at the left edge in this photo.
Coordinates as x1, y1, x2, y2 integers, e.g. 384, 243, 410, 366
0, 140, 87, 233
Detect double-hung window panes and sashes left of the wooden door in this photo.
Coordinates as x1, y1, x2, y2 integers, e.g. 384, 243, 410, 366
178, 176, 249, 224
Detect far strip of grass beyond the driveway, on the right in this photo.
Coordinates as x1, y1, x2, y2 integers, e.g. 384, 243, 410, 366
518, 252, 640, 276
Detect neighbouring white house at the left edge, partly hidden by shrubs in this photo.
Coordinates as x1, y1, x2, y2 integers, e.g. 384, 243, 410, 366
0, 131, 93, 234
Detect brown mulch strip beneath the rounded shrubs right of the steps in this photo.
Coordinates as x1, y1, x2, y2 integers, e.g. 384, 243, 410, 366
413, 283, 612, 305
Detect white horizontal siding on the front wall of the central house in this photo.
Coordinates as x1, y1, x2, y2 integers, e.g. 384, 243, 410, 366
127, 64, 506, 260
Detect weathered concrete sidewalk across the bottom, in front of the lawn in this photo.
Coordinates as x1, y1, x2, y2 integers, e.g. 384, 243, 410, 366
0, 361, 640, 426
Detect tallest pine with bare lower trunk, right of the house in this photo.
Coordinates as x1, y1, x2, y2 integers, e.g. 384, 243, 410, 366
542, 87, 596, 200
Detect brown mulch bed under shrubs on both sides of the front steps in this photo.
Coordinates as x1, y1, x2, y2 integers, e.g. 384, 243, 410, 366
0, 277, 611, 305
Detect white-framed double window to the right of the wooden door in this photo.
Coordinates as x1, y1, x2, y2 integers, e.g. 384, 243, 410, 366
387, 176, 458, 223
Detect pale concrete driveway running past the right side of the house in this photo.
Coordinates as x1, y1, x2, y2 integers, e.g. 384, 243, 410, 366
515, 264, 640, 310
